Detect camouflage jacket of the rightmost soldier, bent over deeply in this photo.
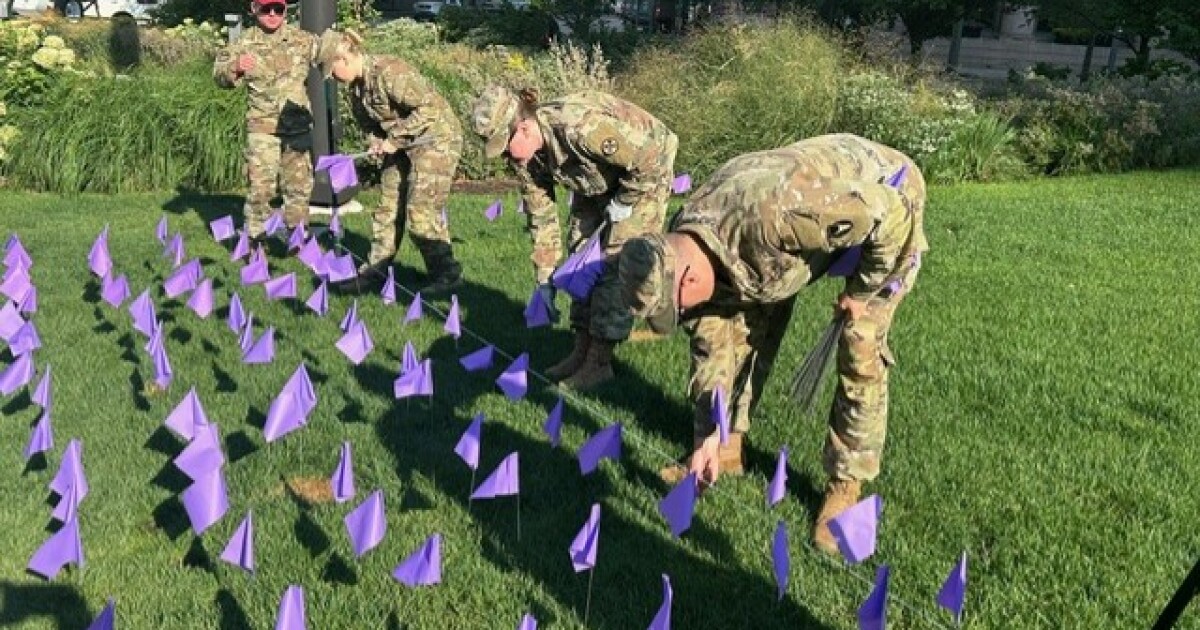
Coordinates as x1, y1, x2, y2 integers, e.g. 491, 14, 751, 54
671, 134, 929, 305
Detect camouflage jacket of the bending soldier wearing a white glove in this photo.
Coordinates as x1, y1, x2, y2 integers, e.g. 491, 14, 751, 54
517, 91, 678, 215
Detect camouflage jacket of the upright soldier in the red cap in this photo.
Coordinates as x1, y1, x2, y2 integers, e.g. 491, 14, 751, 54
212, 24, 318, 136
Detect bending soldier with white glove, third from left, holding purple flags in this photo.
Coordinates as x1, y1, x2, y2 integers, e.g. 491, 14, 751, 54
472, 86, 679, 390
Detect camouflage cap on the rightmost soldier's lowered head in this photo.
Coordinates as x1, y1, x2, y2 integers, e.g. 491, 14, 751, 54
617, 234, 679, 335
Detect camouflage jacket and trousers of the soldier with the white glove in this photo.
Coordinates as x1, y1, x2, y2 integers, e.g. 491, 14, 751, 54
517, 91, 679, 342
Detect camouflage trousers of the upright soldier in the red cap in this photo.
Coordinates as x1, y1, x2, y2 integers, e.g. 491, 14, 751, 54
245, 132, 312, 236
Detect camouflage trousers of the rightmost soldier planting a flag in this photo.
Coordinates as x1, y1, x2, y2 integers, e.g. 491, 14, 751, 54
684, 260, 918, 481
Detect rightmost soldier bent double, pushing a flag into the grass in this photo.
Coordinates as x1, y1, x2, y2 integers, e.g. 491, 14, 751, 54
620, 134, 929, 553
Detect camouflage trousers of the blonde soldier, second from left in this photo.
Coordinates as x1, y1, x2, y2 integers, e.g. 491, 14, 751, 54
367, 138, 462, 268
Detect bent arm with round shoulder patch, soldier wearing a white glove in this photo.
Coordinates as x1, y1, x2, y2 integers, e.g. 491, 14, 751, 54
578, 114, 673, 205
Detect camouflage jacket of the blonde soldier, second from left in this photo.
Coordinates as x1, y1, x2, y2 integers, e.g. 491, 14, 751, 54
350, 54, 462, 146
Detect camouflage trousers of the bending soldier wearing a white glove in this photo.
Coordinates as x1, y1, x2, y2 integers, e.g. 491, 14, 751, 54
568, 178, 671, 343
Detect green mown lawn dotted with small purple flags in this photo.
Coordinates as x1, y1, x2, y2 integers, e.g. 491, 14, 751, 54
0, 172, 1200, 629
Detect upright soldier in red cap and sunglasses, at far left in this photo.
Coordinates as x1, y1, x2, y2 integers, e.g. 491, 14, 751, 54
212, 0, 317, 239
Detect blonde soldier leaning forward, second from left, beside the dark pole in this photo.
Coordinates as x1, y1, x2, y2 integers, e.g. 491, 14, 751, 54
317, 30, 462, 293
